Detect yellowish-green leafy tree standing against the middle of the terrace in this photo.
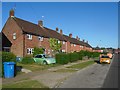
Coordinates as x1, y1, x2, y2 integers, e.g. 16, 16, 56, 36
49, 38, 62, 53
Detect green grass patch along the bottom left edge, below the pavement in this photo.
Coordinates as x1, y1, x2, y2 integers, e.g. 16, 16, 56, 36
2, 80, 48, 88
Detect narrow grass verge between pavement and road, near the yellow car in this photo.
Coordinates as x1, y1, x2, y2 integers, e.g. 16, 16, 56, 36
67, 60, 95, 69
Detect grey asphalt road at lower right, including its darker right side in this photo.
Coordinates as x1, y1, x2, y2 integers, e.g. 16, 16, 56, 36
58, 55, 118, 88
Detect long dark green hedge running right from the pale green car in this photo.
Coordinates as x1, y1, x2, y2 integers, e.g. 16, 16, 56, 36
55, 50, 100, 64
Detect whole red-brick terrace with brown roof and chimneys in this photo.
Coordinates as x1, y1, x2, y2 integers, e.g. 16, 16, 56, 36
2, 10, 92, 57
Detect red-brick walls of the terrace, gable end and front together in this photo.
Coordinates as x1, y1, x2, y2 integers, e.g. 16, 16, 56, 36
2, 18, 92, 57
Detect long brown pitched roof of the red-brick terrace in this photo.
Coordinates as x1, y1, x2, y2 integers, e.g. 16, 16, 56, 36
12, 17, 91, 47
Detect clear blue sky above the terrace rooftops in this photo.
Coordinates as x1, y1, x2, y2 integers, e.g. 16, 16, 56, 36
2, 2, 118, 48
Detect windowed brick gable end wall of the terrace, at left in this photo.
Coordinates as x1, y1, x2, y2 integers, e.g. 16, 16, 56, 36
2, 18, 23, 56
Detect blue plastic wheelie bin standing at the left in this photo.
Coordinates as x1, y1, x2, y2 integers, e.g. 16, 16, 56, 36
3, 62, 15, 78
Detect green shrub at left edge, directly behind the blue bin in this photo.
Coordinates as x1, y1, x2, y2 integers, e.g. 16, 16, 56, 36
2, 52, 16, 62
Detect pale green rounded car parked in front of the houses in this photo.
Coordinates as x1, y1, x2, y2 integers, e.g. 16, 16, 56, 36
33, 54, 56, 65
